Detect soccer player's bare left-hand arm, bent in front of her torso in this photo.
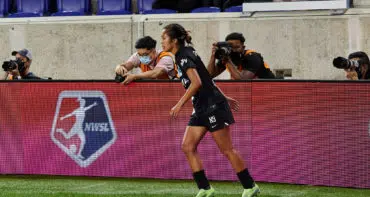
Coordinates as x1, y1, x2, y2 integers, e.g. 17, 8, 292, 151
170, 68, 202, 118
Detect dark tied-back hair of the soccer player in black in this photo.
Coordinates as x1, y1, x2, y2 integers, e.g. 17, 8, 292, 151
164, 23, 192, 45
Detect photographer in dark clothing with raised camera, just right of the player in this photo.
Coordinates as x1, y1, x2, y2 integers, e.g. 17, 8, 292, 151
207, 33, 275, 80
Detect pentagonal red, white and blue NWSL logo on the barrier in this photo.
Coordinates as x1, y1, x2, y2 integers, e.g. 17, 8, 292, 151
51, 91, 117, 167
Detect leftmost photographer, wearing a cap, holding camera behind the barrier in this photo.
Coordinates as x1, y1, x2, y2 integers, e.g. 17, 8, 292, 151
2, 49, 40, 80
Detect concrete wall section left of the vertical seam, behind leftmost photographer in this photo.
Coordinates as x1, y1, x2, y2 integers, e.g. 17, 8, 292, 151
0, 17, 132, 79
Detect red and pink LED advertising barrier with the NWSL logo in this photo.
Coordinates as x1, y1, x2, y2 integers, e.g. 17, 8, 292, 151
0, 81, 370, 188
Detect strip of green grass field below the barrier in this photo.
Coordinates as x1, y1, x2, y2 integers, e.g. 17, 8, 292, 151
0, 175, 370, 197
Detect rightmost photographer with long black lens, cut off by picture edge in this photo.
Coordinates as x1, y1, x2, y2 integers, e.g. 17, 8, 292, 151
333, 51, 370, 80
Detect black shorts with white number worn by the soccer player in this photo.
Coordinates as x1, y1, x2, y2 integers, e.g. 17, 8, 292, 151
188, 102, 235, 132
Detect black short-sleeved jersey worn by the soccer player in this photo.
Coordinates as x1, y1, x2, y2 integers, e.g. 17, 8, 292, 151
176, 47, 226, 115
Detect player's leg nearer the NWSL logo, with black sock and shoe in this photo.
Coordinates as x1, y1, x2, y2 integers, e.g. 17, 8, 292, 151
181, 126, 214, 197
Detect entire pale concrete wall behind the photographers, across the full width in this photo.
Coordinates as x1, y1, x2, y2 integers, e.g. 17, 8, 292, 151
0, 9, 370, 79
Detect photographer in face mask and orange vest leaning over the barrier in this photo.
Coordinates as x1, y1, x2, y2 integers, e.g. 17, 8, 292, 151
115, 36, 176, 85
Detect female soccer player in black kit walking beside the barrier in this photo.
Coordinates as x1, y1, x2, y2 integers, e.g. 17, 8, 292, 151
162, 24, 259, 197
